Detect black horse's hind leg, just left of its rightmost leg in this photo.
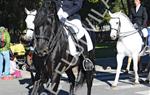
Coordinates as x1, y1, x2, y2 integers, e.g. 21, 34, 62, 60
66, 69, 75, 95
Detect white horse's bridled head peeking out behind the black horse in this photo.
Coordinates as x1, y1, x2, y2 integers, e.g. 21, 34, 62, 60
22, 8, 37, 41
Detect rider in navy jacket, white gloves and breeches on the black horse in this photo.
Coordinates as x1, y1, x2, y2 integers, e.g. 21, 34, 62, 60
57, 0, 93, 55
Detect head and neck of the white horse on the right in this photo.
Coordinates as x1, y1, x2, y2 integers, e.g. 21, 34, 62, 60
109, 11, 137, 40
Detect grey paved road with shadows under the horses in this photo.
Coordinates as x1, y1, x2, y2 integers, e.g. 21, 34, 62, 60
0, 58, 150, 95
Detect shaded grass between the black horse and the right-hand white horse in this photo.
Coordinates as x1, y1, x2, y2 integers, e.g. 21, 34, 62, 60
95, 42, 116, 58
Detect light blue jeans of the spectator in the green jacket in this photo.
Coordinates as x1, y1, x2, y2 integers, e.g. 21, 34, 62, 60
0, 50, 10, 77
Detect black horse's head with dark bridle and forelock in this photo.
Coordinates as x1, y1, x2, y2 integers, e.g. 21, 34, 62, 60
34, 1, 59, 56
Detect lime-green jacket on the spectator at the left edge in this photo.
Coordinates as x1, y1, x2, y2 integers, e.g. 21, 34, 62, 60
0, 27, 10, 52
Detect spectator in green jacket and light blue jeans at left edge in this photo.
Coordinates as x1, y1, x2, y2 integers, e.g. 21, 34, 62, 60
0, 27, 13, 80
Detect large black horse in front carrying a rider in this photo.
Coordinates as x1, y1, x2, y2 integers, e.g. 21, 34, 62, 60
31, 0, 94, 95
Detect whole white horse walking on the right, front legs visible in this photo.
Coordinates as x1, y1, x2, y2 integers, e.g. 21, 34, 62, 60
109, 12, 146, 87
